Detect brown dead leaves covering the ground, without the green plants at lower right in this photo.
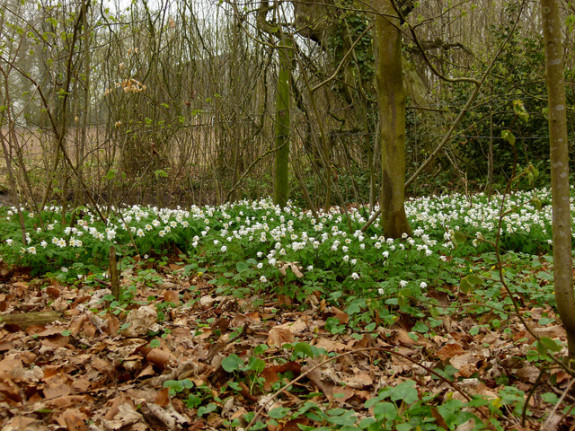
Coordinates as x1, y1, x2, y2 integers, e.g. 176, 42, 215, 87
0, 263, 569, 431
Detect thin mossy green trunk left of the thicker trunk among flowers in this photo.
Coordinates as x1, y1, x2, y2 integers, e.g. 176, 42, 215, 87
274, 36, 292, 207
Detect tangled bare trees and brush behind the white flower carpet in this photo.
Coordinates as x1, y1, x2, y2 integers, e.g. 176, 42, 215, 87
0, 0, 575, 208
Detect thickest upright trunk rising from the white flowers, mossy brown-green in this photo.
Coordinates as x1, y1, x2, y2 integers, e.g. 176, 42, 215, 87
374, 0, 411, 238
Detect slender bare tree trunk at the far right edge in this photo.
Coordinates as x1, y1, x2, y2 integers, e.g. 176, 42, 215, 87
541, 0, 575, 361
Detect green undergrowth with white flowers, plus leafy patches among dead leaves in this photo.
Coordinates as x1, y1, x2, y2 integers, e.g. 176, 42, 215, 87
0, 189, 563, 431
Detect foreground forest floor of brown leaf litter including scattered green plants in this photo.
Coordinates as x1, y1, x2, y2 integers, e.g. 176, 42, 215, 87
0, 257, 575, 431
